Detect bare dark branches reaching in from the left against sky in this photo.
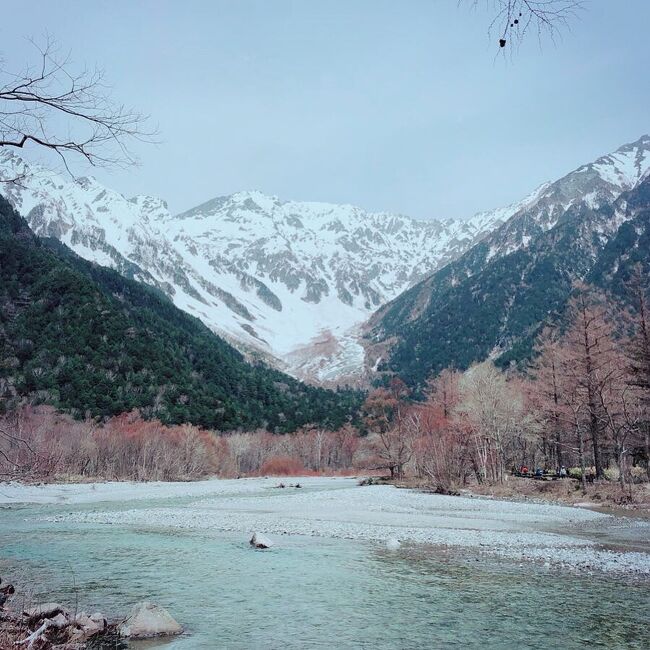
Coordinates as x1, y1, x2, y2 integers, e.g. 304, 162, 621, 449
0, 38, 155, 180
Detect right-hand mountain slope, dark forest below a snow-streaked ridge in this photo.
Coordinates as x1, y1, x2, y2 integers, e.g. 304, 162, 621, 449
366, 136, 650, 385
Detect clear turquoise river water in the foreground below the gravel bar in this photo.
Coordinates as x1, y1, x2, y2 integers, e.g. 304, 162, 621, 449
0, 504, 650, 650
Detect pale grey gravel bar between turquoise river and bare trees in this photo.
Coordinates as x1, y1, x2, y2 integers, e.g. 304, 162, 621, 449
0, 478, 650, 576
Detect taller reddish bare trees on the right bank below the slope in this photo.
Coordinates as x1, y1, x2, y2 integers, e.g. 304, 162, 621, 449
364, 272, 650, 487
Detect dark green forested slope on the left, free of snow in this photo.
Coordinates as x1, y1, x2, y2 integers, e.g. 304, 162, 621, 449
0, 197, 360, 431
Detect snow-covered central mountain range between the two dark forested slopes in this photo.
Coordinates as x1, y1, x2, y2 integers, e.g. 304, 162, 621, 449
0, 152, 508, 382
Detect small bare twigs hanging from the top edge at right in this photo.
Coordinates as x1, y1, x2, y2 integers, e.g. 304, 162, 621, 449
472, 0, 584, 48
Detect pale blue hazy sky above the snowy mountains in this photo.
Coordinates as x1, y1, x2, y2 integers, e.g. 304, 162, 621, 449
0, 0, 650, 218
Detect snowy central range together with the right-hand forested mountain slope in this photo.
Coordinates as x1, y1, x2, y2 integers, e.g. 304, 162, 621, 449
0, 136, 650, 386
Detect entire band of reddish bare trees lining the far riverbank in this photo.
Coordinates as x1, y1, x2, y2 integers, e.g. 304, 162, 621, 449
0, 277, 650, 503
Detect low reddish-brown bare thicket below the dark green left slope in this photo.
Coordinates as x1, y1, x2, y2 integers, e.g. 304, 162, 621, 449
0, 404, 375, 481
